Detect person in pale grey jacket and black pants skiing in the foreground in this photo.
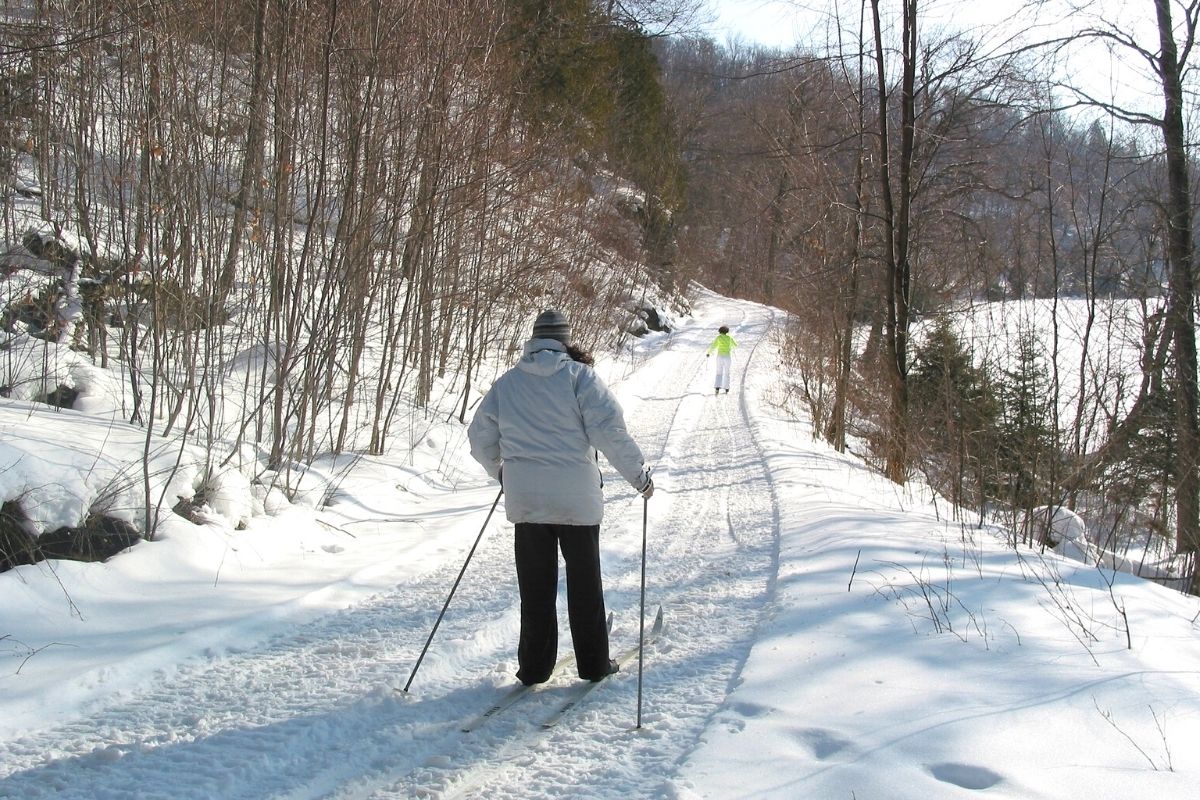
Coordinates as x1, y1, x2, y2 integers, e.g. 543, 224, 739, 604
467, 311, 654, 686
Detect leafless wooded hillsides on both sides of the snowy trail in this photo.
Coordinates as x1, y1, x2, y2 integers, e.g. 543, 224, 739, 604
0, 0, 1200, 594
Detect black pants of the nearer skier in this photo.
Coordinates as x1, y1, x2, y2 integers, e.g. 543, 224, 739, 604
515, 522, 608, 684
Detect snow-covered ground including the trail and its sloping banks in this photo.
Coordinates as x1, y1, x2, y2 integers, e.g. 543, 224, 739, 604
0, 295, 1200, 800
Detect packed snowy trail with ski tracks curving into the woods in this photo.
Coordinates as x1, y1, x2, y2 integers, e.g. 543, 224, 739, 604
0, 299, 779, 800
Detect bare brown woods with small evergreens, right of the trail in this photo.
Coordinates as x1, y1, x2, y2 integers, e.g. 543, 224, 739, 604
660, 1, 1198, 594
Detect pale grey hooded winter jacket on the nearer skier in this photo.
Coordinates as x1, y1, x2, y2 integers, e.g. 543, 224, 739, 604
467, 339, 649, 525
